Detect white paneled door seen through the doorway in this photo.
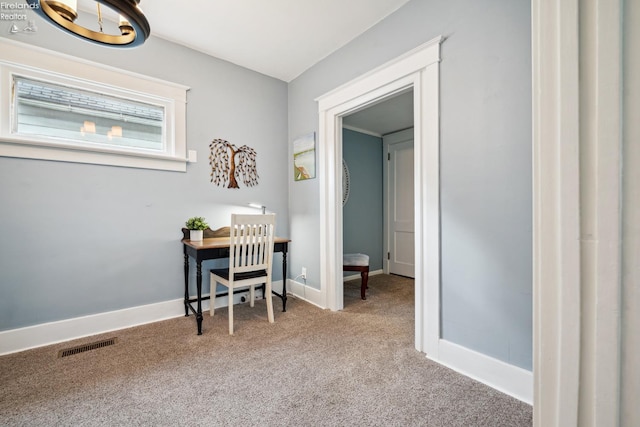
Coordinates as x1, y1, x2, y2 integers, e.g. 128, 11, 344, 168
383, 129, 415, 277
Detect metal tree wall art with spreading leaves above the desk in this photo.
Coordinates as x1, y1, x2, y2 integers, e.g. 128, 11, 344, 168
209, 139, 259, 188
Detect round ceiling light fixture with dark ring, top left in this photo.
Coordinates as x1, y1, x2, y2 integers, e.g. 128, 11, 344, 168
27, 0, 151, 47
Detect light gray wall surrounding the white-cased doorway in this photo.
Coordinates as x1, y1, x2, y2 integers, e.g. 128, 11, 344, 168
289, 0, 532, 369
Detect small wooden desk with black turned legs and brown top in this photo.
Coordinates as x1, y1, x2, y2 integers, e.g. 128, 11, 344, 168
182, 237, 291, 335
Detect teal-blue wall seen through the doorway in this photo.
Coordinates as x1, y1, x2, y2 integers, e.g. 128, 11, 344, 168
342, 129, 383, 271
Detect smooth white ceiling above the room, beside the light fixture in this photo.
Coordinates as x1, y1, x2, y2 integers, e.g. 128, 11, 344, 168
140, 0, 409, 82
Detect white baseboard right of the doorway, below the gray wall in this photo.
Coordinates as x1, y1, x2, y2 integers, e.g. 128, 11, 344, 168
427, 339, 533, 405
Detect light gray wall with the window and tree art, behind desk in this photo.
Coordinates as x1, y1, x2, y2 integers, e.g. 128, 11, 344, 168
0, 18, 289, 330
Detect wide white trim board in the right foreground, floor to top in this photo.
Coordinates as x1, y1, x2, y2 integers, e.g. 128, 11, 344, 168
532, 0, 624, 427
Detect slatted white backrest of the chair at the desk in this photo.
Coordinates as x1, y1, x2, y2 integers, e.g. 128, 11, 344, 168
229, 214, 275, 274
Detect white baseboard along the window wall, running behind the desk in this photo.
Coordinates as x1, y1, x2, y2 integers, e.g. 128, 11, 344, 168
0, 280, 282, 356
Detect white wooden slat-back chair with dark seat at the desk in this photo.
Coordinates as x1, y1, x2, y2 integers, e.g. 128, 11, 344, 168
209, 214, 276, 335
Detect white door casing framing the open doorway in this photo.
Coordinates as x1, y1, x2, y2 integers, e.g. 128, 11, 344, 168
316, 37, 443, 354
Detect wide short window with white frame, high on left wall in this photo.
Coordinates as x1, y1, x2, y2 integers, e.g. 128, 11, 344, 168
0, 39, 188, 171
